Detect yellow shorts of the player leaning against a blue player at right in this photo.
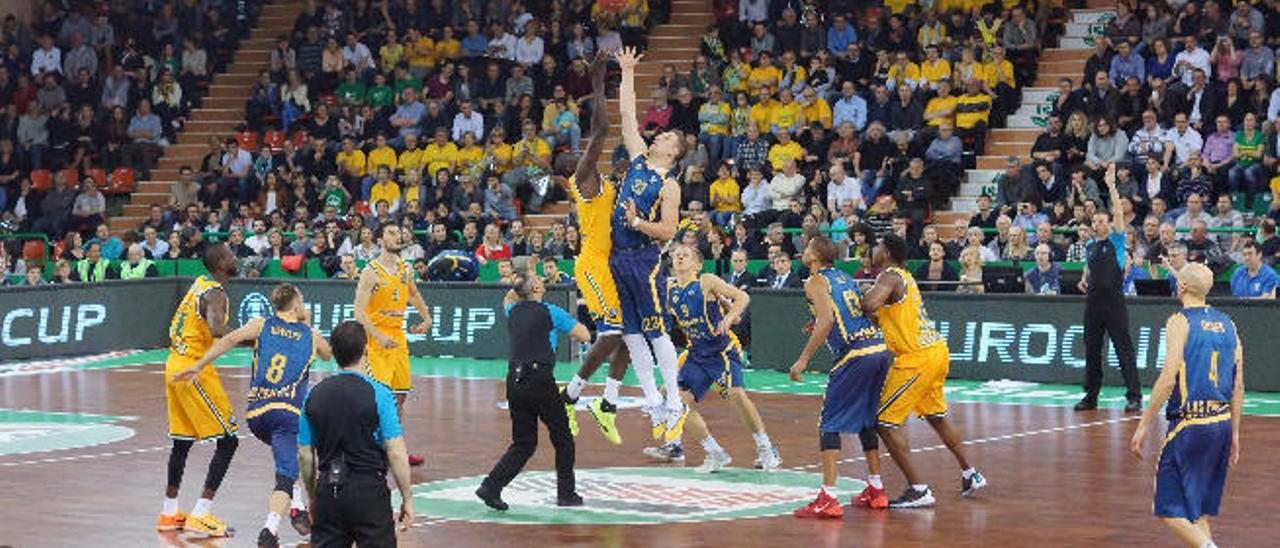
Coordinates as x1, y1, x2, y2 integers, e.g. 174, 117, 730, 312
876, 344, 951, 428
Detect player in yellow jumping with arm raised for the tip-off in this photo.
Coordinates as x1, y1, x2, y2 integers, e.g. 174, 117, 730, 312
561, 54, 630, 444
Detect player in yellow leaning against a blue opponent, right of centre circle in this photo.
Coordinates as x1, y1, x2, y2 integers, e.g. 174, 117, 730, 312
861, 234, 987, 508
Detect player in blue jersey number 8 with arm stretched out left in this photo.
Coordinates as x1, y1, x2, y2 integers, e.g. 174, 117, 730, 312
174, 284, 333, 547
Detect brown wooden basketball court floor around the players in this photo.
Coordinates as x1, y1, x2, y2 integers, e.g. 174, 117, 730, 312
0, 365, 1280, 547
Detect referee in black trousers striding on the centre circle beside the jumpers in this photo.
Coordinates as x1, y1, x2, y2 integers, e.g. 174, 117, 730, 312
476, 273, 591, 510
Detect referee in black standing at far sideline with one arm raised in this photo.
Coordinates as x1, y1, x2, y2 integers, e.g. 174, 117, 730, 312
1075, 165, 1142, 412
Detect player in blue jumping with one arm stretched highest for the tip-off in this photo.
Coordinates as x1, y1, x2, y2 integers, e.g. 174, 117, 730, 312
609, 47, 689, 455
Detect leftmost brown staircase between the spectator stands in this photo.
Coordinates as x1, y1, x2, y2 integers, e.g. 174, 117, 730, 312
110, 0, 305, 234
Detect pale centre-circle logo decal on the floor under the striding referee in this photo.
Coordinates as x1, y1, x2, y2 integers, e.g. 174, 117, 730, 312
397, 468, 864, 525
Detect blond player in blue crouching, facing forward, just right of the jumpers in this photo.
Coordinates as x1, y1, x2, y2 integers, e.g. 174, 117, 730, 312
667, 245, 782, 474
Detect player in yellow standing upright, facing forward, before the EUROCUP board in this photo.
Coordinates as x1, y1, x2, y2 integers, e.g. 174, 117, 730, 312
356, 223, 431, 466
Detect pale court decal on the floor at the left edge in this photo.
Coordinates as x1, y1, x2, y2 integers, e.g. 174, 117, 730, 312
0, 408, 133, 457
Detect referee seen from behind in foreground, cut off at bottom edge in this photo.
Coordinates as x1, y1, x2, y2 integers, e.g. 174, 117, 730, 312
298, 321, 413, 548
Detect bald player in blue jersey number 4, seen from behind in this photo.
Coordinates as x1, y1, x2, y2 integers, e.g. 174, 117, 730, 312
1129, 262, 1244, 548
